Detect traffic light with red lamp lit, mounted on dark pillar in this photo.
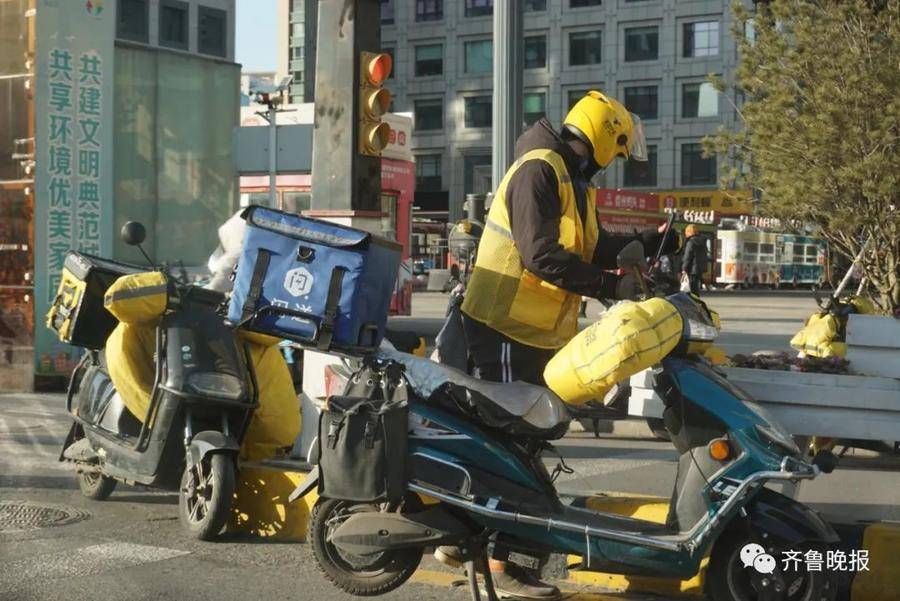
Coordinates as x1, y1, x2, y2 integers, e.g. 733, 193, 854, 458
359, 52, 393, 157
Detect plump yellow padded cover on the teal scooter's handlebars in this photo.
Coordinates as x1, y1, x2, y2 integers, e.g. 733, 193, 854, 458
544, 298, 682, 404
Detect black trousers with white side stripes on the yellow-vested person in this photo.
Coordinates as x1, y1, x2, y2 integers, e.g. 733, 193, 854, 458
463, 313, 556, 386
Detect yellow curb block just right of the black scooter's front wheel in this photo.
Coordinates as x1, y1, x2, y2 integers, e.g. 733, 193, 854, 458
227, 464, 318, 542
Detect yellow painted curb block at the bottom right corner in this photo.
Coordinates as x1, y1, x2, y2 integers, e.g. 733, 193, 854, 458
850, 523, 900, 601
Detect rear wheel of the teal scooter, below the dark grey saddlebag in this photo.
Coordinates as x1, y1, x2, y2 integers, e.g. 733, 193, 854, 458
309, 499, 422, 597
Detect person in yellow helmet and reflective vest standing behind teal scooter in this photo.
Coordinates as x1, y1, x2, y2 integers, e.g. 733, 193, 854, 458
435, 91, 671, 600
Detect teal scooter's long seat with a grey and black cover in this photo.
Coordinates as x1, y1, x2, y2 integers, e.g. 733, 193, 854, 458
383, 351, 571, 440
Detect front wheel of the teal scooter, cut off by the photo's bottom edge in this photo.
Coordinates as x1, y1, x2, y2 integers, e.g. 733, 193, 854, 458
706, 531, 837, 601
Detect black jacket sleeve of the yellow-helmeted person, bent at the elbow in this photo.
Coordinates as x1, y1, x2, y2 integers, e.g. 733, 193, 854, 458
506, 161, 617, 298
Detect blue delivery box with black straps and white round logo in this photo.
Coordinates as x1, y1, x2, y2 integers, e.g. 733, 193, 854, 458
228, 206, 401, 352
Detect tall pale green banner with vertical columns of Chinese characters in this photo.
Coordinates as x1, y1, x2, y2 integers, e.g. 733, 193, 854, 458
34, 0, 115, 376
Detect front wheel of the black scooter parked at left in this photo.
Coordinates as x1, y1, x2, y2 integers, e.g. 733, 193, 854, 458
178, 453, 235, 541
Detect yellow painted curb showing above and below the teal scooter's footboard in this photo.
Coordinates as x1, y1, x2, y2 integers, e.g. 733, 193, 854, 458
568, 493, 709, 596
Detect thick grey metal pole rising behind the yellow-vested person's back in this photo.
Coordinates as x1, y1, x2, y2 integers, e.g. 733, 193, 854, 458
491, 0, 525, 190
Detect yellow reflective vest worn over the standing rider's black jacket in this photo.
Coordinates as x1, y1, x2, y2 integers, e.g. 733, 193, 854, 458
462, 149, 600, 349
